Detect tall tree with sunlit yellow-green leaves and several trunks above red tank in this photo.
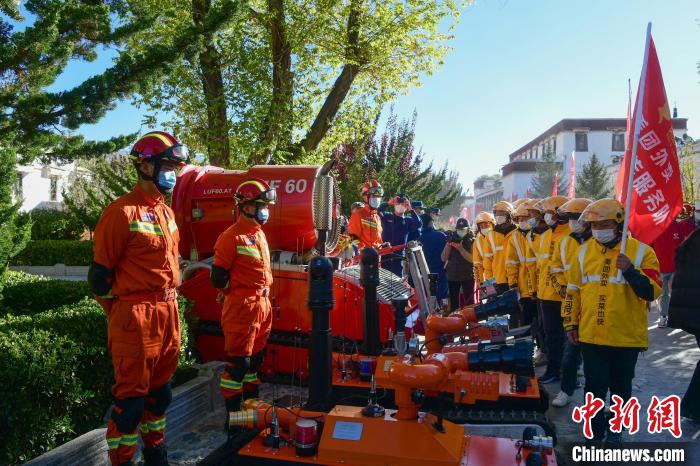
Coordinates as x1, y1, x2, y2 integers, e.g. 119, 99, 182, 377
128, 0, 459, 168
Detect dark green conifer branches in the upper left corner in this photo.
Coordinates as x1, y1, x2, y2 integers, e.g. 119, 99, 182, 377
0, 0, 242, 271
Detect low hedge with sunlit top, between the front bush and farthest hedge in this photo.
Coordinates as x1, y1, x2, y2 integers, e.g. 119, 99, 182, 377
0, 271, 91, 315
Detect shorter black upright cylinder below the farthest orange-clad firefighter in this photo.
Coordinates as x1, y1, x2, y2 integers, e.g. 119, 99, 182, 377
360, 248, 382, 356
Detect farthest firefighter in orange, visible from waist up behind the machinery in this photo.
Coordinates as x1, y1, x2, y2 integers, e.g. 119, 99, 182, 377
348, 180, 384, 249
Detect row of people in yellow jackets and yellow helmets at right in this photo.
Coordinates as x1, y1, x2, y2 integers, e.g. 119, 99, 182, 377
472, 196, 662, 443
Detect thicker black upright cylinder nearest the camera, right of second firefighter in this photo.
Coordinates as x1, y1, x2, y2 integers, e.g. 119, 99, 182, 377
307, 256, 334, 411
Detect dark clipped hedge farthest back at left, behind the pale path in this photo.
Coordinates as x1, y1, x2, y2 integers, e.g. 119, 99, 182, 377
10, 240, 92, 265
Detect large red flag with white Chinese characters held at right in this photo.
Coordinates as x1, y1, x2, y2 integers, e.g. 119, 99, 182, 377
620, 33, 683, 244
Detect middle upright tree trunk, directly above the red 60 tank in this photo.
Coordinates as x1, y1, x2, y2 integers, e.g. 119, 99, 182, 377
252, 0, 294, 163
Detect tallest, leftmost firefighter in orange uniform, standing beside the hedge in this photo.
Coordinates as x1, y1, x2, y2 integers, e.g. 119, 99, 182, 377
88, 131, 188, 466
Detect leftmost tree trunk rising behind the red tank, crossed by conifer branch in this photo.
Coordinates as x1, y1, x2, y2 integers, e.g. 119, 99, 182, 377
192, 0, 231, 167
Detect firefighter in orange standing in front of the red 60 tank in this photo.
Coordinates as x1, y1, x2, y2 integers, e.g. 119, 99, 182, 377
211, 179, 277, 426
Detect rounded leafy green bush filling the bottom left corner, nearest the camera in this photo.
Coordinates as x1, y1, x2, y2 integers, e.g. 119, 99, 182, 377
0, 329, 87, 464
